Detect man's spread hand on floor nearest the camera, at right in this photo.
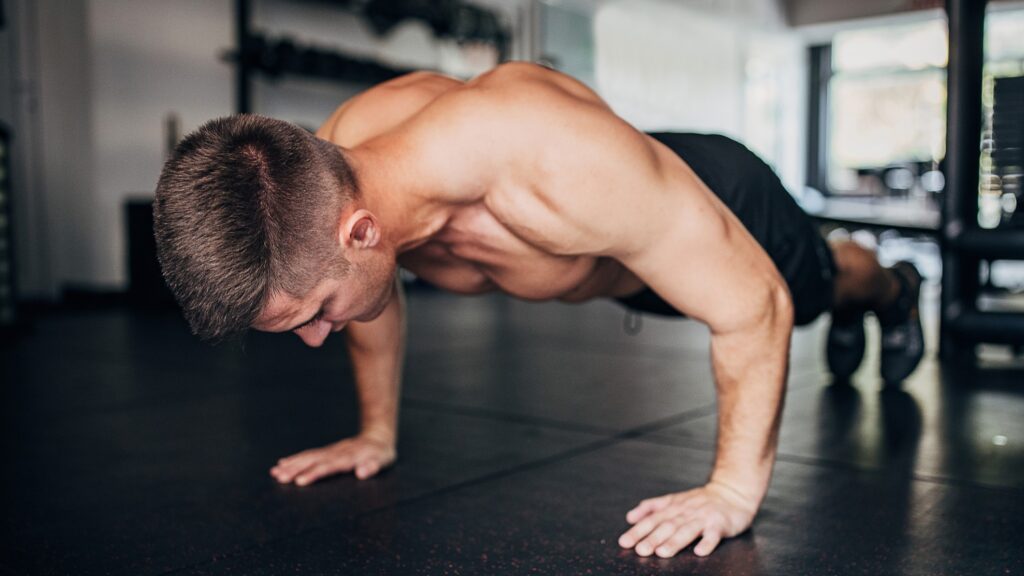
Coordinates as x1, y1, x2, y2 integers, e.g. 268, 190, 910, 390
618, 482, 758, 558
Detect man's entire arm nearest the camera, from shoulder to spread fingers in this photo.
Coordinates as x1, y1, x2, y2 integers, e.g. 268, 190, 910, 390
598, 142, 793, 558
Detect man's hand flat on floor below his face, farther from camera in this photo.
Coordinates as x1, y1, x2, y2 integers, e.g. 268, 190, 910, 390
270, 434, 395, 486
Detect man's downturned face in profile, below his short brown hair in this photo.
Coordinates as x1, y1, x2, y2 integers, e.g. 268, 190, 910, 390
253, 255, 395, 347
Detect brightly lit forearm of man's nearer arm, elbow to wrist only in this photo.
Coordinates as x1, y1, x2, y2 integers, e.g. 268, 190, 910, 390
711, 290, 793, 505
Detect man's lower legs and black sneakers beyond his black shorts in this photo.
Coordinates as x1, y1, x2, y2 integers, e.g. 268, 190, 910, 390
826, 241, 924, 383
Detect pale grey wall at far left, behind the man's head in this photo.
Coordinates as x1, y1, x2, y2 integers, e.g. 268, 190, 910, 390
0, 0, 231, 299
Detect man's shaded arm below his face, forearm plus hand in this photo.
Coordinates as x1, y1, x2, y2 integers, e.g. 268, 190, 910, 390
270, 281, 406, 486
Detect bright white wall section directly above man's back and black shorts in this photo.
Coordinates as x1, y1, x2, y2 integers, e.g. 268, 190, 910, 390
594, 0, 806, 192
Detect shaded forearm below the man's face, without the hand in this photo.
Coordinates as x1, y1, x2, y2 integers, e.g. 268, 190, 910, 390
345, 282, 406, 443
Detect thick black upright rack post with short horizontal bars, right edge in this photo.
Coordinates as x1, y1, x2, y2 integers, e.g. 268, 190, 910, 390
940, 0, 1024, 362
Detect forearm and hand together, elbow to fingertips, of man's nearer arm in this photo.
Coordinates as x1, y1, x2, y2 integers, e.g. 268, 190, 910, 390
618, 261, 793, 558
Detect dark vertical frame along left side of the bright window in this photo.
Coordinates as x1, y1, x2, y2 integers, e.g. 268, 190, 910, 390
807, 44, 831, 195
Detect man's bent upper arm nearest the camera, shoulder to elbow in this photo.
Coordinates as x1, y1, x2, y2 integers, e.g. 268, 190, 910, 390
552, 142, 785, 333
